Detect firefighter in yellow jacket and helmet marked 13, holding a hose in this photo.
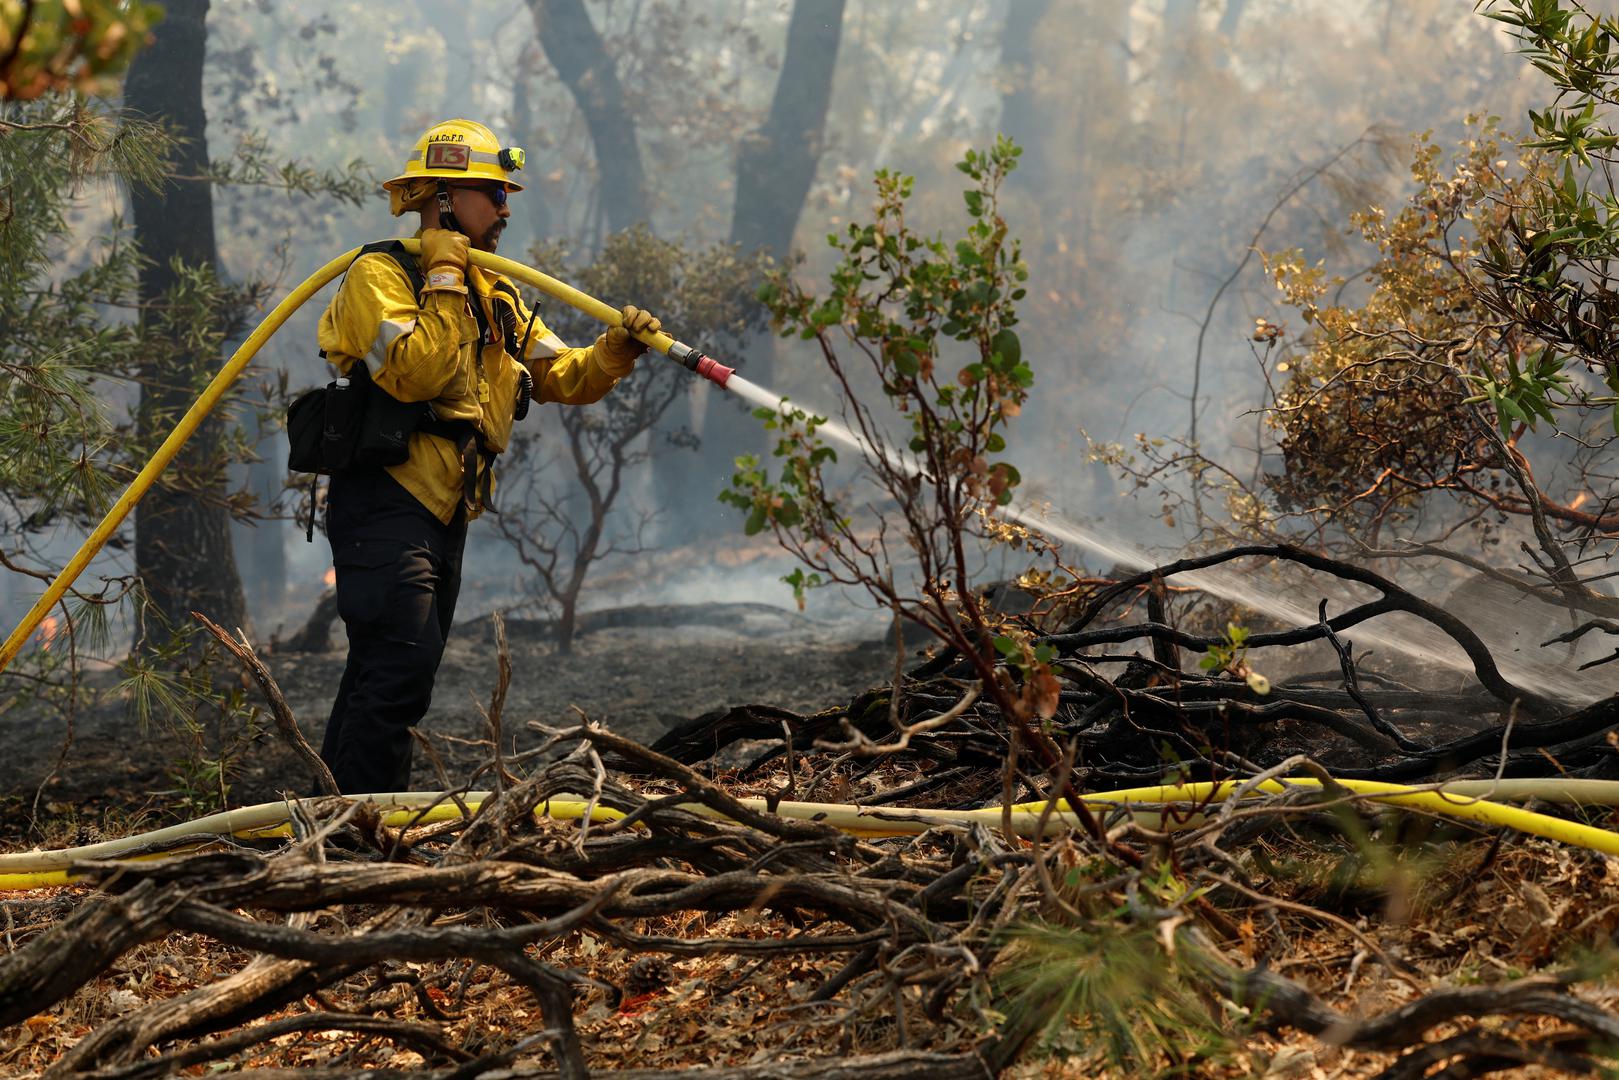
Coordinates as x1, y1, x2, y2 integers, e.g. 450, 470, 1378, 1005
319, 120, 661, 793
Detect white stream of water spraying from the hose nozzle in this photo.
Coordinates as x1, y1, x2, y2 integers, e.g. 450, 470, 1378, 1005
724, 376, 1611, 703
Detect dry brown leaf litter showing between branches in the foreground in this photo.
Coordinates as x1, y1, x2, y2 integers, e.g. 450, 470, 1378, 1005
9, 764, 1619, 1078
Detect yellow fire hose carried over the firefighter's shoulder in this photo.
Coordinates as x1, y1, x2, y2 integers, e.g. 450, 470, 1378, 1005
0, 240, 732, 672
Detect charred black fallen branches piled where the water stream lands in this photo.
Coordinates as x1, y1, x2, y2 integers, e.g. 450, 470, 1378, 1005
654, 546, 1619, 793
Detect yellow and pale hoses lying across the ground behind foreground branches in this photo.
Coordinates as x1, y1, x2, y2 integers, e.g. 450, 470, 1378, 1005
0, 779, 1619, 891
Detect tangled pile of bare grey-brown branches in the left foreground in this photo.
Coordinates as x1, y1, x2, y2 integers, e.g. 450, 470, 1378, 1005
0, 727, 1028, 1078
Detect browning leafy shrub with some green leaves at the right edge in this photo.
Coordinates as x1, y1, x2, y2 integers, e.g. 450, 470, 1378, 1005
1094, 0, 1619, 662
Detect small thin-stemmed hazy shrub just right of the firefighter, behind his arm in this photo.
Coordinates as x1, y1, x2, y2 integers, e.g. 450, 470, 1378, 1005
494, 225, 764, 654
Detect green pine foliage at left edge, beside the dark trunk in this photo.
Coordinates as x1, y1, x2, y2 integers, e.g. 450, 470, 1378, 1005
0, 101, 168, 708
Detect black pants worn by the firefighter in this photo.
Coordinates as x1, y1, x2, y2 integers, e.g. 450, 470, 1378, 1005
321, 470, 466, 795
